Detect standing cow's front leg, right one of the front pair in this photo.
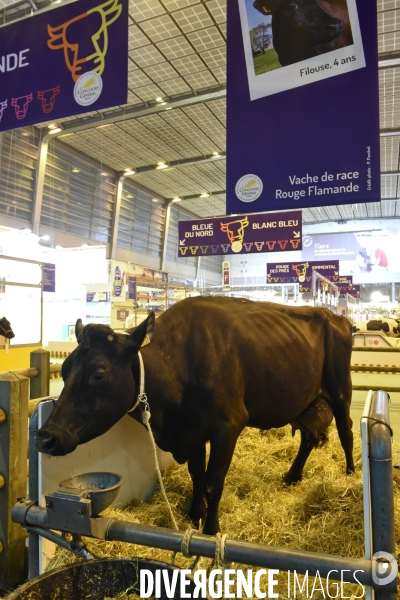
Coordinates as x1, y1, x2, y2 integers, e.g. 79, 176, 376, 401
203, 427, 243, 535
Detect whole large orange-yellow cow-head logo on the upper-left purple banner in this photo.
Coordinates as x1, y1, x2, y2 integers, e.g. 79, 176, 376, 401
47, 0, 122, 82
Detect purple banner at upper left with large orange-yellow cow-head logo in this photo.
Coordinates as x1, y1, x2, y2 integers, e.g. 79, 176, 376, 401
0, 0, 128, 131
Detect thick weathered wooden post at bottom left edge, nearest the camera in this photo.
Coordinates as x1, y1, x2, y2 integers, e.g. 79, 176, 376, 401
0, 372, 29, 590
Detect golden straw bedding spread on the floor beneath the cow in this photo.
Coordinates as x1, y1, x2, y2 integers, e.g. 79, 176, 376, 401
45, 426, 400, 600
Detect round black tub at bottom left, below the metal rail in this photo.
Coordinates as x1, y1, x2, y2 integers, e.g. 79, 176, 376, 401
5, 558, 195, 600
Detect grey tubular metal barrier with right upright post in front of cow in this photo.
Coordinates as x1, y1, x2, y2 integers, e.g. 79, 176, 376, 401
7, 391, 397, 600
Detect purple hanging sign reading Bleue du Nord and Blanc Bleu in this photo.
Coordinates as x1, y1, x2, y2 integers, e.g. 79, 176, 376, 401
178, 210, 302, 256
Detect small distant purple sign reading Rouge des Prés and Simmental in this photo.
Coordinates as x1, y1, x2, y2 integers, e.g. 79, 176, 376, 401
267, 260, 339, 292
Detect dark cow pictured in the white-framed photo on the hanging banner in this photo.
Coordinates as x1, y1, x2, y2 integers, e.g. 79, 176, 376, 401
253, 0, 342, 66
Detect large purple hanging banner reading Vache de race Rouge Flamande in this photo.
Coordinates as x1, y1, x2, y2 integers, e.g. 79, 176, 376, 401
226, 0, 380, 214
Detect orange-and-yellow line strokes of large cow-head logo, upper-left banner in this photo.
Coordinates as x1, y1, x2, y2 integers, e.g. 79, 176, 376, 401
47, 0, 122, 82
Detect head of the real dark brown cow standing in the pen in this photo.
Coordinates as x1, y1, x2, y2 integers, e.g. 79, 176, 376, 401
36, 312, 155, 456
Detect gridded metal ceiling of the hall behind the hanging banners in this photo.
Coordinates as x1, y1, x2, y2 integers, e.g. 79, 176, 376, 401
0, 0, 400, 223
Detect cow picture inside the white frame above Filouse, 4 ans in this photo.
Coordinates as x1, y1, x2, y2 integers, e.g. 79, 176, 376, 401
245, 0, 353, 75
